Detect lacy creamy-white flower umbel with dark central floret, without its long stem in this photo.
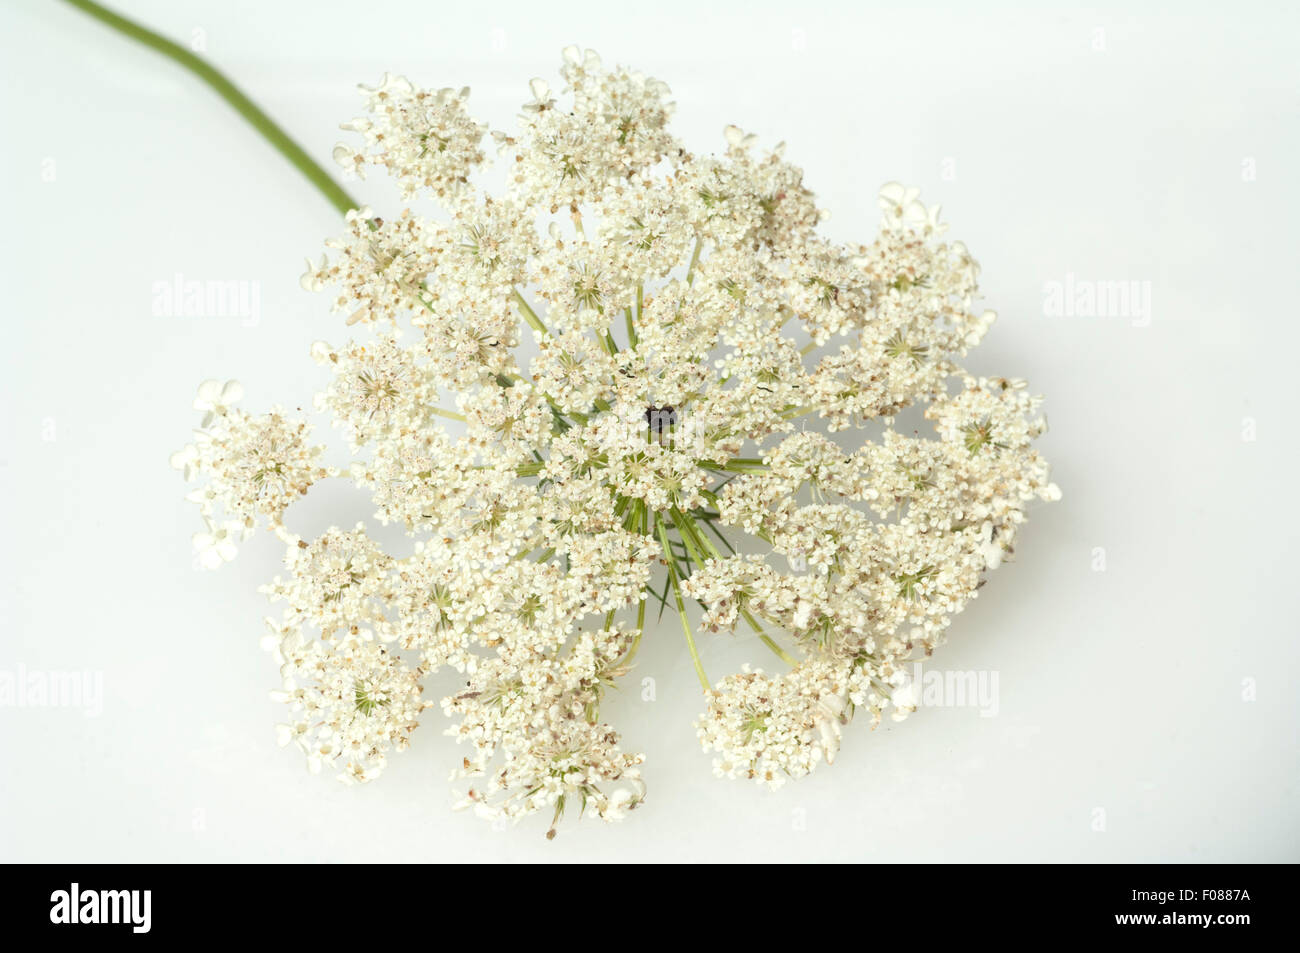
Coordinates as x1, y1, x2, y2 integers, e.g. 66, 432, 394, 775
173, 49, 1060, 833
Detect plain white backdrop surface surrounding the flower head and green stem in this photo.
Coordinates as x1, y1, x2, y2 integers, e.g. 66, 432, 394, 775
0, 0, 1300, 863
